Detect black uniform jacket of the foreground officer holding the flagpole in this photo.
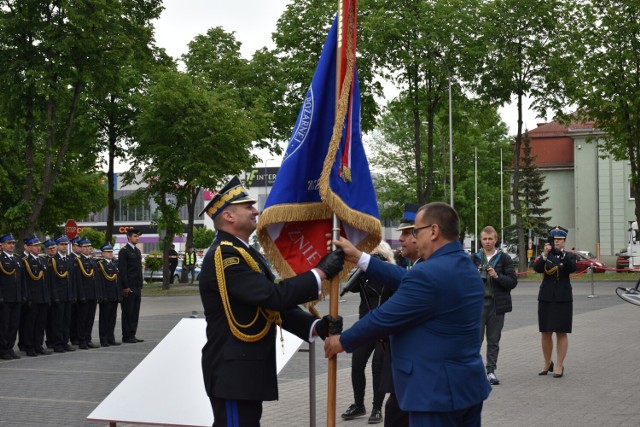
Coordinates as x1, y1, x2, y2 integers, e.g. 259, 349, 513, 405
200, 231, 318, 401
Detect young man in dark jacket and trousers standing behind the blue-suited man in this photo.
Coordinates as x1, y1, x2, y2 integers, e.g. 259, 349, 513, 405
471, 225, 518, 385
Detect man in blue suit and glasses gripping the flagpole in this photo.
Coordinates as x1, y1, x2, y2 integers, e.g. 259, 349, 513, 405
325, 203, 491, 427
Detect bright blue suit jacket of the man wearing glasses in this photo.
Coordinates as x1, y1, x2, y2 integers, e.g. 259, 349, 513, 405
340, 241, 491, 412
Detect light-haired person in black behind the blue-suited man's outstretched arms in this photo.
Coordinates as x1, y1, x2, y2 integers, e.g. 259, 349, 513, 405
342, 241, 395, 424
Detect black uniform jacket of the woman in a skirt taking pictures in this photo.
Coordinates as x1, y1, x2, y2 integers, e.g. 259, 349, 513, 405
533, 251, 577, 302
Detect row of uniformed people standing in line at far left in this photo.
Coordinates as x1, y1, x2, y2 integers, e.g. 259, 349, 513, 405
0, 229, 143, 360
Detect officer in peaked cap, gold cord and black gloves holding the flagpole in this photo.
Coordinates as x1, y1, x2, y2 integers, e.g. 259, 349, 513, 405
200, 177, 344, 426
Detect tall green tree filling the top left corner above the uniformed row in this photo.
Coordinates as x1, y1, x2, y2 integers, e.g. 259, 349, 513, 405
0, 0, 159, 242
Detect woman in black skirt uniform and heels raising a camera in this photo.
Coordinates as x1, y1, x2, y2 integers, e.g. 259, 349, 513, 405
533, 226, 577, 378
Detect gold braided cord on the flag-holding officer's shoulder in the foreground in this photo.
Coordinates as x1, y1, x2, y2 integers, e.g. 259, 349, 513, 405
214, 241, 282, 342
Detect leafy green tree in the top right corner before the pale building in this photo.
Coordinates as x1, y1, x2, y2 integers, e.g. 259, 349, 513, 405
557, 0, 640, 224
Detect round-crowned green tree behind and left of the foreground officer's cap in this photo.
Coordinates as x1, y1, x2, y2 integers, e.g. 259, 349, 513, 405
126, 71, 256, 289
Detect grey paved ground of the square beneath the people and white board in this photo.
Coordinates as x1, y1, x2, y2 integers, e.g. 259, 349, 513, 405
0, 282, 640, 427
